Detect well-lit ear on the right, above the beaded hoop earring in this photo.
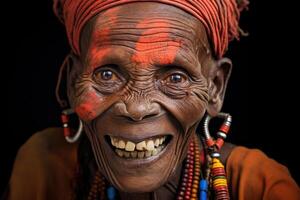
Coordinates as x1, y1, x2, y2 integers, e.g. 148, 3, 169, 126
207, 58, 232, 117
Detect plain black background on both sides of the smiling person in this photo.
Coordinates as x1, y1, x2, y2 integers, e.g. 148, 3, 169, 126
0, 0, 300, 194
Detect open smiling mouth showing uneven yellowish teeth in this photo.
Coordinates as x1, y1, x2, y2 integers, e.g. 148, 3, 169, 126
106, 135, 171, 159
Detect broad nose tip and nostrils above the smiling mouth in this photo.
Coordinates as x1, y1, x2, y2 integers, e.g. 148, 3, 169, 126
115, 101, 162, 121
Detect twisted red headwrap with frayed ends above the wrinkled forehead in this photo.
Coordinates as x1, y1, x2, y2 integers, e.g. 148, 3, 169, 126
54, 0, 247, 58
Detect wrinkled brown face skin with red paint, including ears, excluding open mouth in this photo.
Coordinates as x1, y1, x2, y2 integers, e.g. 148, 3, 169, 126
68, 3, 231, 199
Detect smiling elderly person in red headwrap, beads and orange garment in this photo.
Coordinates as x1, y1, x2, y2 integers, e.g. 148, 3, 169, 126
7, 0, 300, 200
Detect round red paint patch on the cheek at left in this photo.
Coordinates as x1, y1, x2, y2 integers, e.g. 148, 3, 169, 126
75, 90, 103, 121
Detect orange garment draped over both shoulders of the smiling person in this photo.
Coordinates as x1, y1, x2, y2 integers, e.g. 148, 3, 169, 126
4, 128, 300, 200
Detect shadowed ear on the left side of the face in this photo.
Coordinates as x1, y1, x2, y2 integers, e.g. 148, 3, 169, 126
67, 54, 83, 108
